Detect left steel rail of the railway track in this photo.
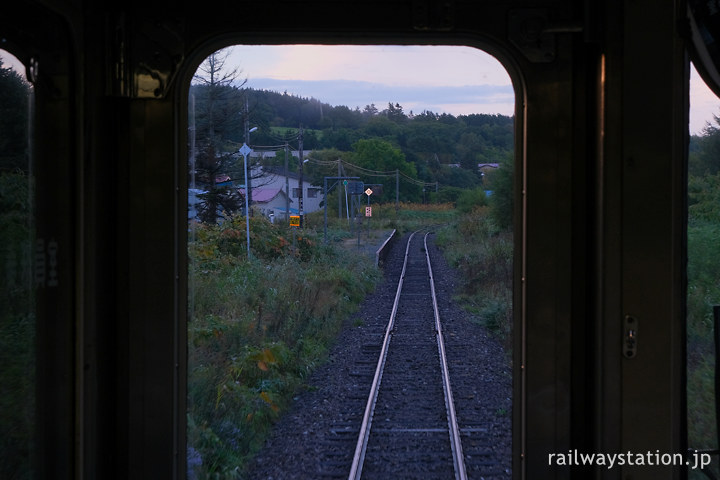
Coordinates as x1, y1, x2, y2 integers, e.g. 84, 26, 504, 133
348, 232, 416, 480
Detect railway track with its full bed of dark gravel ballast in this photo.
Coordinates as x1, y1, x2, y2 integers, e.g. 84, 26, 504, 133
250, 233, 511, 480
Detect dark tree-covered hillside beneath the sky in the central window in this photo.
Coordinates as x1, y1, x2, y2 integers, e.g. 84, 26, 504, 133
191, 85, 514, 193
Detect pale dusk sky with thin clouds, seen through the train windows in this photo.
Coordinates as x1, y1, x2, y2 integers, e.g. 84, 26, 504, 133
0, 45, 720, 135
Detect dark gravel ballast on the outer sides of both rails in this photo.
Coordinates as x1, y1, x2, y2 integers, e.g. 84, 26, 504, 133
244, 235, 512, 480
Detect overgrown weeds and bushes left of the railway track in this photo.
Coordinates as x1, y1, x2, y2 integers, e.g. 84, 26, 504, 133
188, 218, 379, 479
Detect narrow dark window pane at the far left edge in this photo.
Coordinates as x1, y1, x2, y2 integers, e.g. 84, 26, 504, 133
0, 50, 35, 478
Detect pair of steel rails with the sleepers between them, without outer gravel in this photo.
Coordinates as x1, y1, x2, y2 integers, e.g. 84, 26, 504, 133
348, 233, 467, 480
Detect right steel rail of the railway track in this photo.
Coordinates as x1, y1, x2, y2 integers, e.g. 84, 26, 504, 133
423, 232, 467, 480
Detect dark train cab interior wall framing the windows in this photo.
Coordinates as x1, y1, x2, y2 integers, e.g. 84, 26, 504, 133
0, 0, 720, 479
